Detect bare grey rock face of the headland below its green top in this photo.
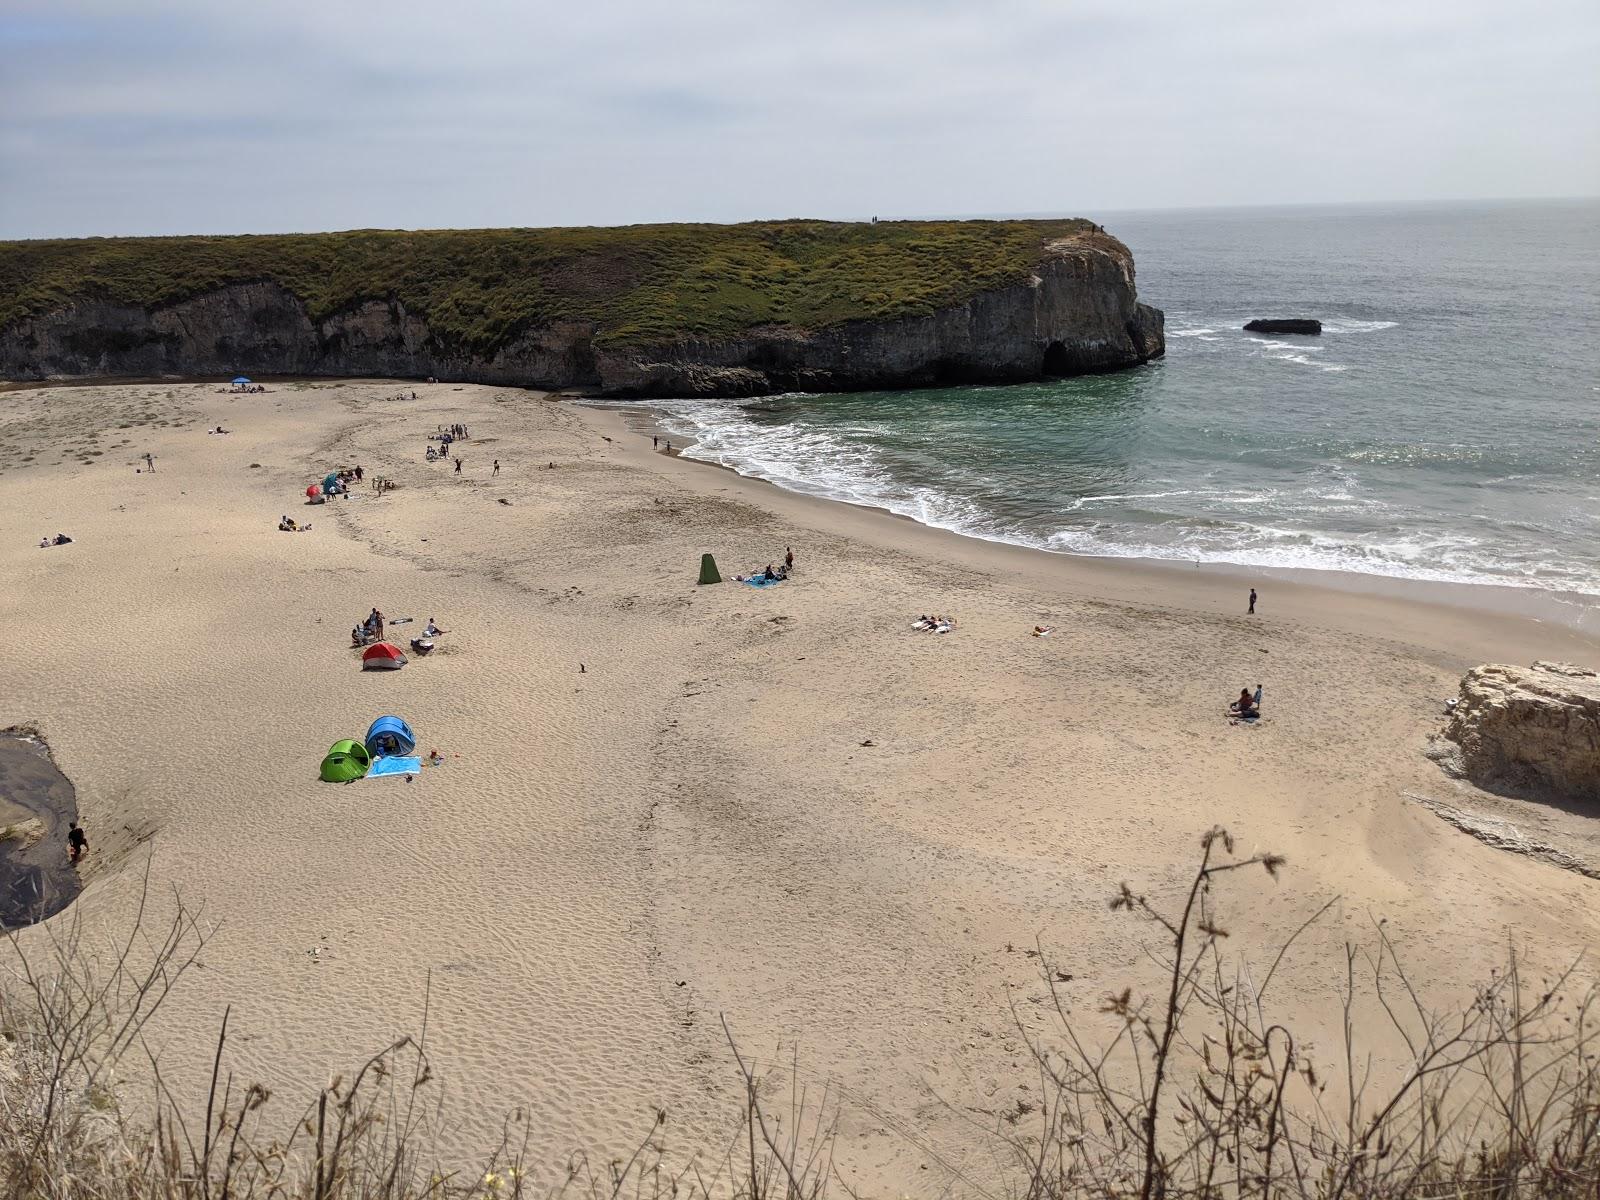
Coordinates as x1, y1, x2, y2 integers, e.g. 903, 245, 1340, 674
0, 234, 1165, 397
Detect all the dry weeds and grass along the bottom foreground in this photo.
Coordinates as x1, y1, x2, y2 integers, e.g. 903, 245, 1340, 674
0, 829, 1600, 1200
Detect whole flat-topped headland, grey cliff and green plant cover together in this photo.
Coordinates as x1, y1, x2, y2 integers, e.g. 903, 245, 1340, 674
0, 221, 1165, 397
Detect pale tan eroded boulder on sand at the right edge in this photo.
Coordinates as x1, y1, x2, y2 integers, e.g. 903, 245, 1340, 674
1435, 662, 1600, 805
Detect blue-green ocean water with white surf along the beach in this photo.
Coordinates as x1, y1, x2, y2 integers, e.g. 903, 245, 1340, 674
640, 202, 1600, 597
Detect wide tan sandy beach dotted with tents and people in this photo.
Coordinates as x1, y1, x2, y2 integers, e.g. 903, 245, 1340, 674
0, 381, 1600, 1195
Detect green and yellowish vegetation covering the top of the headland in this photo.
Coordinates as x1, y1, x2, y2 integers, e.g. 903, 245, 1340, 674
0, 219, 1115, 354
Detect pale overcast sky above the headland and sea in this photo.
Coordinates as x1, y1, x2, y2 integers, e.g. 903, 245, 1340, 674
0, 0, 1600, 237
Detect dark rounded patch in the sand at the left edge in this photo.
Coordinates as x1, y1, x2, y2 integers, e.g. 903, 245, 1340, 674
0, 728, 82, 930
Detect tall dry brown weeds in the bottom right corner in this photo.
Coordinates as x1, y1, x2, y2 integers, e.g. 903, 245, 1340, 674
1005, 827, 1600, 1200
